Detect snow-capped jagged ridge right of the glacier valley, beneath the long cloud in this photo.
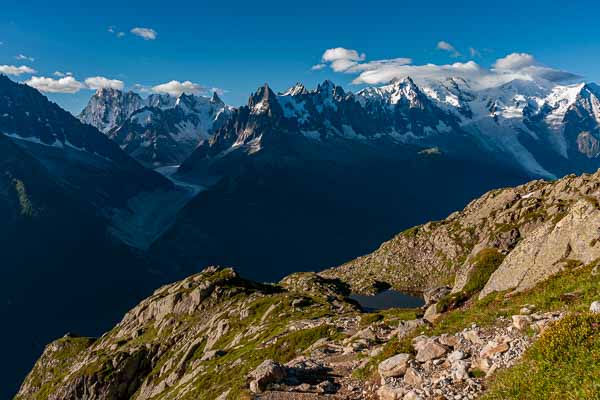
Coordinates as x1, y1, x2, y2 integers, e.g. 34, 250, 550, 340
181, 77, 600, 178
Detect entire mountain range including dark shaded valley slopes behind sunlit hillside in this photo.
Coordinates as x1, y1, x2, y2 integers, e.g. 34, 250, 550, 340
0, 71, 600, 394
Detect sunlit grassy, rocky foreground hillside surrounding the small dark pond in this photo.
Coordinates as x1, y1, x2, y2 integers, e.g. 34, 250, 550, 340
16, 172, 600, 400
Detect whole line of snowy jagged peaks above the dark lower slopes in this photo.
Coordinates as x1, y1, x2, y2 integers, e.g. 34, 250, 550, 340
80, 77, 600, 178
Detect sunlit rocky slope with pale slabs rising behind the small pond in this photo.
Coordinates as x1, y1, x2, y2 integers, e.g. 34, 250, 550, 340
323, 171, 600, 297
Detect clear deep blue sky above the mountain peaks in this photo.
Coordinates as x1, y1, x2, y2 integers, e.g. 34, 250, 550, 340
0, 0, 600, 112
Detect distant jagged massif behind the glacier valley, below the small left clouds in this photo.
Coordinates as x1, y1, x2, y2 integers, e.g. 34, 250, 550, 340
79, 89, 231, 167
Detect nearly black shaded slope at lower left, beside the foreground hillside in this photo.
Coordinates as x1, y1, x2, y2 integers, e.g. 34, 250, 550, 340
0, 135, 176, 398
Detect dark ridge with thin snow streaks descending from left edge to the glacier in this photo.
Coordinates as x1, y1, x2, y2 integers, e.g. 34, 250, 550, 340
0, 76, 171, 206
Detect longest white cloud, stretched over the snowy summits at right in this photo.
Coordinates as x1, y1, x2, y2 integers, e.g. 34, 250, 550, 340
319, 48, 578, 88
